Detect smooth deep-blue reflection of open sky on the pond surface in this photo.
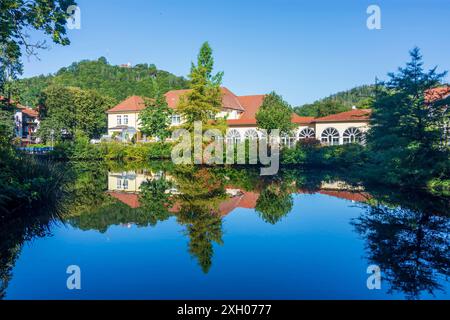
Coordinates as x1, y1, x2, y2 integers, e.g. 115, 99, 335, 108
6, 194, 450, 299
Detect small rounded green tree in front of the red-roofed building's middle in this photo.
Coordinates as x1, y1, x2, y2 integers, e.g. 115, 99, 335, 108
256, 91, 294, 134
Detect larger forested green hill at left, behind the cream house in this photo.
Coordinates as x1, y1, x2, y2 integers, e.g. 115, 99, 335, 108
18, 57, 188, 106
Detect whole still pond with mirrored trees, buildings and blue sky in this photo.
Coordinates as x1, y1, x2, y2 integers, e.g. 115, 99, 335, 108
0, 162, 450, 299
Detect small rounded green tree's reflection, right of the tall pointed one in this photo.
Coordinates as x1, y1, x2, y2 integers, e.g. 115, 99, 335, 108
255, 182, 293, 224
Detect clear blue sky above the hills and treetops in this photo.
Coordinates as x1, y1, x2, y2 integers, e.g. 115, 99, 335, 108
24, 0, 450, 105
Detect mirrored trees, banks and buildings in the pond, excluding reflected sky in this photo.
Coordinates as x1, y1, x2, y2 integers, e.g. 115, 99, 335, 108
0, 162, 450, 299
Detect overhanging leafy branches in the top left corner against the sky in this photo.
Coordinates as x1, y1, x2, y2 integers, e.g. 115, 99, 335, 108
0, 0, 75, 92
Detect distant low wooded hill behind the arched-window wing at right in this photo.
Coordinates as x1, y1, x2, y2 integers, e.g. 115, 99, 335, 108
295, 85, 375, 117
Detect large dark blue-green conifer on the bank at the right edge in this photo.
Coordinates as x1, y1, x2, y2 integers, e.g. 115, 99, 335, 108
368, 48, 450, 186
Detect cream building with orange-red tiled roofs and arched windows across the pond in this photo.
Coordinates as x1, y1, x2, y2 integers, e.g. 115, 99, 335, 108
107, 87, 370, 144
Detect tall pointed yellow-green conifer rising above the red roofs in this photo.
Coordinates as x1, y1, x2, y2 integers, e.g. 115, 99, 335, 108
178, 42, 223, 128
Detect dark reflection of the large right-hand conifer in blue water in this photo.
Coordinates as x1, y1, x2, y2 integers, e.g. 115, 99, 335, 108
353, 205, 450, 299
